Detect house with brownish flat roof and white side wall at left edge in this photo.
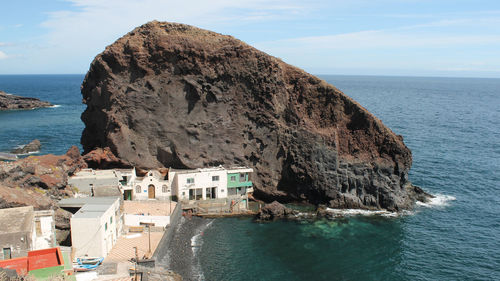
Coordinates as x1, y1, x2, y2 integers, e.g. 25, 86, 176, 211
0, 206, 56, 260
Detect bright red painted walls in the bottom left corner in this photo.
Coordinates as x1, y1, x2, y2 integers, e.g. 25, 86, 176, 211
0, 248, 64, 275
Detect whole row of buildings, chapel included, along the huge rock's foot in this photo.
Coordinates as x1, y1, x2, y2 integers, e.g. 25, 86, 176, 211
68, 166, 253, 201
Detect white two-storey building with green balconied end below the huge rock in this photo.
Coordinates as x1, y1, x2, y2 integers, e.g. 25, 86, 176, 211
168, 166, 253, 201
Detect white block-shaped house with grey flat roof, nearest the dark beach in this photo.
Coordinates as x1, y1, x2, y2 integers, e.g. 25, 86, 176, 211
59, 197, 123, 257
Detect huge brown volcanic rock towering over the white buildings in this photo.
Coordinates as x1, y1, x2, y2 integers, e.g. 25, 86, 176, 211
82, 21, 422, 210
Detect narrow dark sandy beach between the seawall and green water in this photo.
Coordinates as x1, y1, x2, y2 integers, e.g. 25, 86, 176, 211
158, 217, 213, 280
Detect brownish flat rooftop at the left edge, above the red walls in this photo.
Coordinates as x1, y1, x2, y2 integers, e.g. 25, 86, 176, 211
0, 206, 34, 234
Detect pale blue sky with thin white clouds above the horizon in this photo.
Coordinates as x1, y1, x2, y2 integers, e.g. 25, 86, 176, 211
0, 0, 500, 78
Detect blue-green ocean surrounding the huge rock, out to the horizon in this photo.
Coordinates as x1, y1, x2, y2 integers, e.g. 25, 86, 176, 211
0, 75, 500, 280
